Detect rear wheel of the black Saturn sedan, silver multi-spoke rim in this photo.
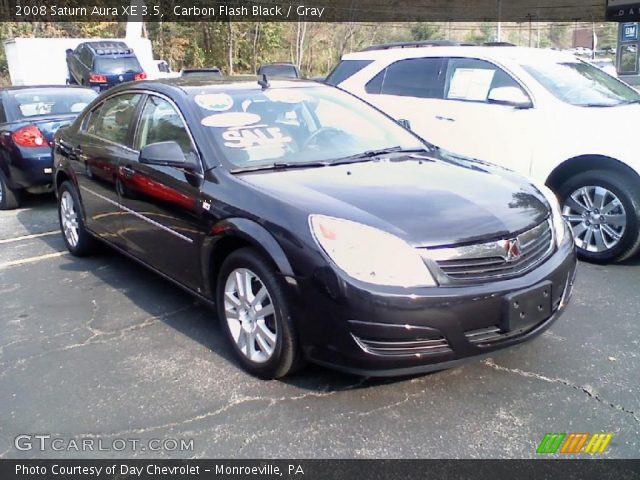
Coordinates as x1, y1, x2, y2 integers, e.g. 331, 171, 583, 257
58, 182, 96, 257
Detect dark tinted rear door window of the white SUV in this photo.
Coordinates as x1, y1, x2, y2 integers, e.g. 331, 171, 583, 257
365, 58, 443, 98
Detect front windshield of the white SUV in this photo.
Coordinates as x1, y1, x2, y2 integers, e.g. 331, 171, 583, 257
522, 60, 640, 107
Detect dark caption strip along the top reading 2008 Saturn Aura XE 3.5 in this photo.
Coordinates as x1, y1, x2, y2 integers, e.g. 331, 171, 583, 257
0, 0, 615, 22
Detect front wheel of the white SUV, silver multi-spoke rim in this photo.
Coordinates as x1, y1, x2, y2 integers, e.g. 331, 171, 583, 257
558, 170, 640, 263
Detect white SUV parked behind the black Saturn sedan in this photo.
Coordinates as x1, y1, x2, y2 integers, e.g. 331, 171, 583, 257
326, 44, 640, 262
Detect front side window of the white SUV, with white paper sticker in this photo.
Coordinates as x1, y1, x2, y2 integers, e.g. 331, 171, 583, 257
444, 58, 528, 102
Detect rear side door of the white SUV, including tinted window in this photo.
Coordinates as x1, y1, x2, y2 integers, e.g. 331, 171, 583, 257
354, 57, 446, 144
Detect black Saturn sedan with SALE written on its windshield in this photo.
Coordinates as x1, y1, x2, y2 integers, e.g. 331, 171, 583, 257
54, 79, 576, 378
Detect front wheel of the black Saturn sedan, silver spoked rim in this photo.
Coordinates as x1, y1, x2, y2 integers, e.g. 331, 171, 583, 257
216, 248, 304, 379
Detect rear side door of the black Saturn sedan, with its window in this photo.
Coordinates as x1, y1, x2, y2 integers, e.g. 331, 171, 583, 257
71, 93, 142, 246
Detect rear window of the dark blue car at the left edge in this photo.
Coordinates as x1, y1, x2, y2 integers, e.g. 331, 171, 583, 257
8, 88, 97, 120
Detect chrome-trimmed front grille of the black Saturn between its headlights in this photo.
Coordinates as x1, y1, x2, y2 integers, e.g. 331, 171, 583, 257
424, 220, 553, 282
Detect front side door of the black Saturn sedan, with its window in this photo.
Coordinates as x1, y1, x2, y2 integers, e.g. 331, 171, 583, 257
118, 94, 204, 290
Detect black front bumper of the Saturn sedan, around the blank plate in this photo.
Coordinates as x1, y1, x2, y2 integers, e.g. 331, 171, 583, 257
296, 235, 577, 376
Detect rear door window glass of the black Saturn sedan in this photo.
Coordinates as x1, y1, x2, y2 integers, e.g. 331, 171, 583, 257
86, 93, 141, 146
